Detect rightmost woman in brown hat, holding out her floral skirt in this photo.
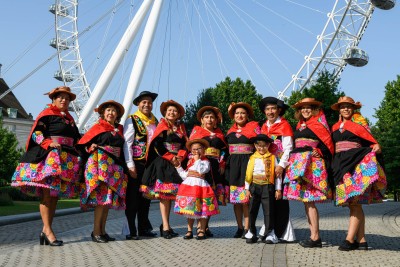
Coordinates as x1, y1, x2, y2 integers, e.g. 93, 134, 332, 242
331, 96, 386, 251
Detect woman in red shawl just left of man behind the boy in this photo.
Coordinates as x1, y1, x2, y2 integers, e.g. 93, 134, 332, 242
225, 102, 260, 238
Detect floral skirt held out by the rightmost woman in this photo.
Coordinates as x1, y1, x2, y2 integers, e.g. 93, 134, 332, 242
335, 152, 387, 206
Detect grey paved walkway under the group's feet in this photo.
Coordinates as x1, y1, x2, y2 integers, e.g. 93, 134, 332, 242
0, 202, 400, 266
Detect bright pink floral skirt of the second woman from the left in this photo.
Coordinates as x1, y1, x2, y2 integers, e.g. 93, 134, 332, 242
81, 150, 128, 210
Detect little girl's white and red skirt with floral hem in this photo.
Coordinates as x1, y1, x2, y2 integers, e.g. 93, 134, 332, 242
174, 177, 220, 219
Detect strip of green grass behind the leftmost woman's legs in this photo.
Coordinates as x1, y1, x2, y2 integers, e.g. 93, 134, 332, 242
0, 198, 79, 216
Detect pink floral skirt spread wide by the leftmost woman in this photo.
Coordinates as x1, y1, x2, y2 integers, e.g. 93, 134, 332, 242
11, 149, 81, 198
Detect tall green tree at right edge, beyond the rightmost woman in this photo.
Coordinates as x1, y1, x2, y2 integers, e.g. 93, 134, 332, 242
372, 75, 400, 193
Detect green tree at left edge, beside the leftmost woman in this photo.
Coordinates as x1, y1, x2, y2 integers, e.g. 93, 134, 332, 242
0, 119, 22, 182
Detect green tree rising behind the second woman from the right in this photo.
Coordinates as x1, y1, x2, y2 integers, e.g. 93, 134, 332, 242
285, 71, 345, 127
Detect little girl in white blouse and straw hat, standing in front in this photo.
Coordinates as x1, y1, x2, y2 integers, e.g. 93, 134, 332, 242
174, 139, 219, 240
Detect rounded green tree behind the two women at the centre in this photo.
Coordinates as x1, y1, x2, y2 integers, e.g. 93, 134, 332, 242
184, 77, 263, 132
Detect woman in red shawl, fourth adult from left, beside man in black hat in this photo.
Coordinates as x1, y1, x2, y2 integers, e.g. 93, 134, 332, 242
140, 100, 187, 239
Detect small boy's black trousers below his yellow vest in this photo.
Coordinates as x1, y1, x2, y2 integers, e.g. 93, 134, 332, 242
249, 184, 275, 239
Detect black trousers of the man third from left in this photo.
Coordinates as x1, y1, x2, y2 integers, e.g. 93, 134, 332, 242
125, 161, 153, 235
